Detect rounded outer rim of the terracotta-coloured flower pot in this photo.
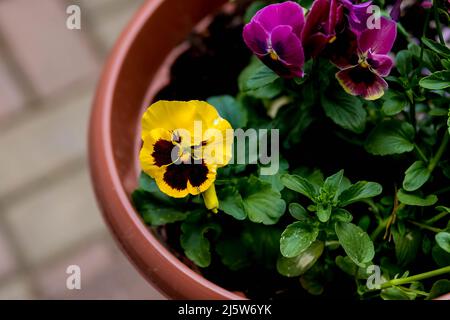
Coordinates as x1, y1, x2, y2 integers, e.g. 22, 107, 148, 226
88, 0, 242, 300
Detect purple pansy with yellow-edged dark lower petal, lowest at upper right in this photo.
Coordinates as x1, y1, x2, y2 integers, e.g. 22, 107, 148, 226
336, 17, 397, 100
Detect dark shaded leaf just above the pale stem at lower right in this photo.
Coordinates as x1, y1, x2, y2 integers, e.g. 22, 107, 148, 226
393, 230, 422, 266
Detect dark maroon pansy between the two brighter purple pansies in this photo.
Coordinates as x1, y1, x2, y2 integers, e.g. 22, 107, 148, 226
302, 0, 343, 57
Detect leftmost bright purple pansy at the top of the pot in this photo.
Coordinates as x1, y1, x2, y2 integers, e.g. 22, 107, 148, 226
243, 1, 305, 78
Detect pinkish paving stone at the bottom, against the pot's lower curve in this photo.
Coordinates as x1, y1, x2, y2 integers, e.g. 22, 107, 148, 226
36, 237, 164, 299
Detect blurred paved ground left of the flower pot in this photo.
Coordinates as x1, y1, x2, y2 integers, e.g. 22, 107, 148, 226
0, 0, 163, 299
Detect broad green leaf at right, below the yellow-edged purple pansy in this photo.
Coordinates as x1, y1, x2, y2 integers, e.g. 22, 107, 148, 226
365, 120, 414, 156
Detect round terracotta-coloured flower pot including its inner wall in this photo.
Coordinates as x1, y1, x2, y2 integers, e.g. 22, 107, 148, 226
89, 0, 241, 299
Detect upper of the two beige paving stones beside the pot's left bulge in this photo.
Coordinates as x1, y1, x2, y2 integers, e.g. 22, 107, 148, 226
0, 89, 92, 198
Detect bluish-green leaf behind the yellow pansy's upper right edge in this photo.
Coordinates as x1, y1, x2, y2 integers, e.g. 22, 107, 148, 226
208, 95, 247, 129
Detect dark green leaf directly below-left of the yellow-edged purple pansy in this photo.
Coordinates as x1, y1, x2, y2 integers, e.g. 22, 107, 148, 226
321, 90, 367, 133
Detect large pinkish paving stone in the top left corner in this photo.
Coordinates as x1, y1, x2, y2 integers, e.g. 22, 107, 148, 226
0, 0, 98, 95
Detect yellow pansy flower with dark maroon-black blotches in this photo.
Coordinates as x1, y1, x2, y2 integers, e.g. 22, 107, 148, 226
139, 101, 233, 212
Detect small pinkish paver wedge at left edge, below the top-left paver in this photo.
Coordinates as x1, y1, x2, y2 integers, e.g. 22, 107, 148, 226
0, 51, 25, 121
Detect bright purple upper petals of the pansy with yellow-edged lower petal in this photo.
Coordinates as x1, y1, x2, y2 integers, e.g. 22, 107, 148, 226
358, 17, 397, 54
